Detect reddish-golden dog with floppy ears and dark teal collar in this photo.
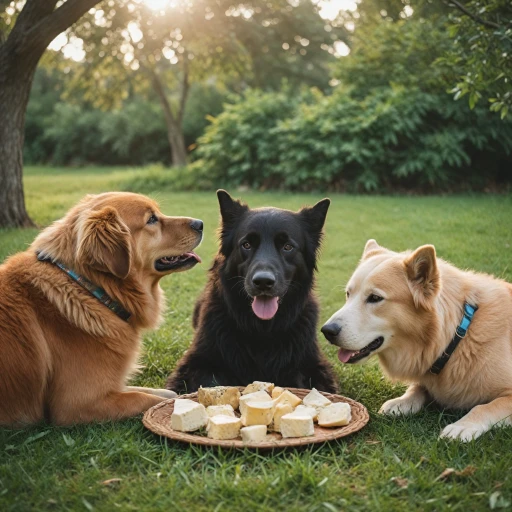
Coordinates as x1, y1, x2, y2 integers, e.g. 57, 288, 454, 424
0, 192, 203, 427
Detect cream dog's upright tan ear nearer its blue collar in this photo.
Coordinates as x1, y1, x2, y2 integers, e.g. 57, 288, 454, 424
404, 245, 441, 309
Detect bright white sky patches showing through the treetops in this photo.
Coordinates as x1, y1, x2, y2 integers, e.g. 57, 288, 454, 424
48, 0, 358, 62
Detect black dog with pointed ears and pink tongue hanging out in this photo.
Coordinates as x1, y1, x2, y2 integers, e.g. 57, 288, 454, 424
167, 190, 337, 393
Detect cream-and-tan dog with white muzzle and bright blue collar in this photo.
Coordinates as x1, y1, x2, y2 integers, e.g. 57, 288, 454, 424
322, 240, 512, 441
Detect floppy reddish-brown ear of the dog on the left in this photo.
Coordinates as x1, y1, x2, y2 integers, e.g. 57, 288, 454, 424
77, 206, 131, 279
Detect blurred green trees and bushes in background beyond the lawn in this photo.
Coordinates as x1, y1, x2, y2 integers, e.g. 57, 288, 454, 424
25, 0, 512, 192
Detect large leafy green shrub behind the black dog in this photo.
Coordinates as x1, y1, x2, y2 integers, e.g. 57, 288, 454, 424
192, 86, 512, 192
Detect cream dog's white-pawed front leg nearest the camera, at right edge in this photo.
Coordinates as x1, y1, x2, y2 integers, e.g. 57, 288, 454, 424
441, 395, 512, 442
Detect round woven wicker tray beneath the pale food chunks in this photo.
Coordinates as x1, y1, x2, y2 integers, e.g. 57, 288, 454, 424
142, 387, 369, 449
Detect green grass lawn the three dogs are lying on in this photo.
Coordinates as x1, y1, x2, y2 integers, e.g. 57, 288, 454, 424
0, 168, 512, 512
